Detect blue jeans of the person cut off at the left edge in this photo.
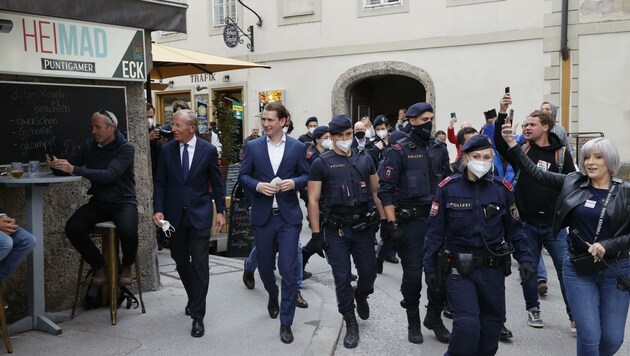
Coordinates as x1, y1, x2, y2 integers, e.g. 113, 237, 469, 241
0, 227, 37, 280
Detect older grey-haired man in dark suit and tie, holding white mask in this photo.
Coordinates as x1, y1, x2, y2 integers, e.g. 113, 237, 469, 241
153, 110, 225, 337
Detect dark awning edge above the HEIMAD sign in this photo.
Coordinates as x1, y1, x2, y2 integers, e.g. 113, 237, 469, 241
0, 0, 188, 33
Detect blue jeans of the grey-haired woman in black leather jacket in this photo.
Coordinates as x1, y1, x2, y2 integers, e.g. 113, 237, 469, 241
563, 253, 630, 356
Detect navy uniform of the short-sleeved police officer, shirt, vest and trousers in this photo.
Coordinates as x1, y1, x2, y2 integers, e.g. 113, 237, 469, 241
309, 151, 378, 314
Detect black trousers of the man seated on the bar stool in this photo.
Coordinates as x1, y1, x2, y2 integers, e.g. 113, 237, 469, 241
66, 202, 138, 269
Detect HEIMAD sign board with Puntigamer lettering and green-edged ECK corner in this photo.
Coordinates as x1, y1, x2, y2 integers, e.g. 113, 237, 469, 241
0, 12, 146, 81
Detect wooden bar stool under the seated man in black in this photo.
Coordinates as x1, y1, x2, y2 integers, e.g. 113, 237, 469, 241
70, 221, 146, 325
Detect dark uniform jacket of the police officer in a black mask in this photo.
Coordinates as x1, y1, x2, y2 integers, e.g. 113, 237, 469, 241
378, 136, 451, 208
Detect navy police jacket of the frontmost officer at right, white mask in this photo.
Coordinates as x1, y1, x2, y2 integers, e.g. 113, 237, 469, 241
424, 173, 532, 274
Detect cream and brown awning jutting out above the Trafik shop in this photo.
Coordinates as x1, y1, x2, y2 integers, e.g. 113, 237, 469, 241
150, 43, 271, 80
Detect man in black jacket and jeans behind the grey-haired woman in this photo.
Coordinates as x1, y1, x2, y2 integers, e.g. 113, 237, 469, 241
494, 94, 575, 331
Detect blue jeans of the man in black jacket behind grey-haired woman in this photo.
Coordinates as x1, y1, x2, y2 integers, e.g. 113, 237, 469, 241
522, 223, 573, 320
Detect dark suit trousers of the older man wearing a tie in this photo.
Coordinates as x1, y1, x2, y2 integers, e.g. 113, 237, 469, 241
170, 211, 210, 320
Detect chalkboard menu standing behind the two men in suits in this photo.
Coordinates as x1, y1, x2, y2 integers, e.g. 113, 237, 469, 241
227, 183, 255, 257
